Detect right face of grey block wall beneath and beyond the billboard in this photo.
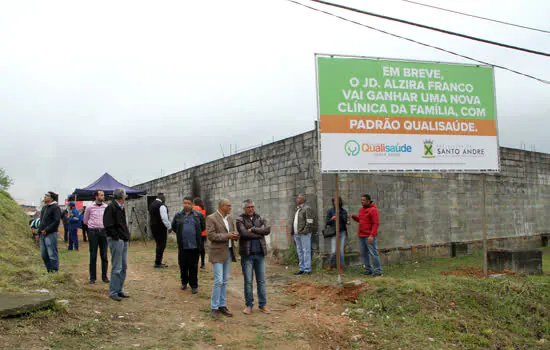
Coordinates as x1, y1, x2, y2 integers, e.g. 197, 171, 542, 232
322, 148, 550, 253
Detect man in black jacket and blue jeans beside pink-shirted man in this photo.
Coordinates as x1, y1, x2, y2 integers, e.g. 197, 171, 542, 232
103, 188, 130, 301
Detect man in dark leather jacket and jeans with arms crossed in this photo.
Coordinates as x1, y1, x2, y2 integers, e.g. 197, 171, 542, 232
235, 199, 271, 315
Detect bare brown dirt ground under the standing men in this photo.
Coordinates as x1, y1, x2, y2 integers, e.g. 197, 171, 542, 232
0, 241, 372, 349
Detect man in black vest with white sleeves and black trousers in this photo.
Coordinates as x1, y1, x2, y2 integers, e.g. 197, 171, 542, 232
149, 193, 172, 268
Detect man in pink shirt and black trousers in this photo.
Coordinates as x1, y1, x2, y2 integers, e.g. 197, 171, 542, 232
84, 190, 109, 284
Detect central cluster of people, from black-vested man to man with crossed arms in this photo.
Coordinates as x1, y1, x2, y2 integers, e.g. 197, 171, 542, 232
149, 193, 271, 319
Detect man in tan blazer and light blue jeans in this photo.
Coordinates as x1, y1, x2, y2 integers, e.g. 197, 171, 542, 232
206, 199, 239, 319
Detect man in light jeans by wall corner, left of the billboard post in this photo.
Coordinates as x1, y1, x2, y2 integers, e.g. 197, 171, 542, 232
291, 194, 315, 275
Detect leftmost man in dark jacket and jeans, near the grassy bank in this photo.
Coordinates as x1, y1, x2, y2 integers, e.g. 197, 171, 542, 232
39, 191, 61, 272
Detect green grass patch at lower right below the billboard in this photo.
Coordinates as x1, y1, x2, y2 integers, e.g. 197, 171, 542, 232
350, 248, 550, 349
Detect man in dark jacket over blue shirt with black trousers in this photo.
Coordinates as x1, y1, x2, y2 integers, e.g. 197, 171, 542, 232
172, 197, 206, 294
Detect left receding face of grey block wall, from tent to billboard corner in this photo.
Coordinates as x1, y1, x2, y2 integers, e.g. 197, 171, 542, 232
128, 132, 319, 249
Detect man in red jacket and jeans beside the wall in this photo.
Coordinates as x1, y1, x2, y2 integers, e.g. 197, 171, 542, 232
351, 194, 382, 277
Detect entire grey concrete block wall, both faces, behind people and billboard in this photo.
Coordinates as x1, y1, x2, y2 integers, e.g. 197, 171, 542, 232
128, 127, 550, 262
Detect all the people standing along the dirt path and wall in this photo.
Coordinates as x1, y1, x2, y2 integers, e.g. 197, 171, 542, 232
33, 188, 382, 319
